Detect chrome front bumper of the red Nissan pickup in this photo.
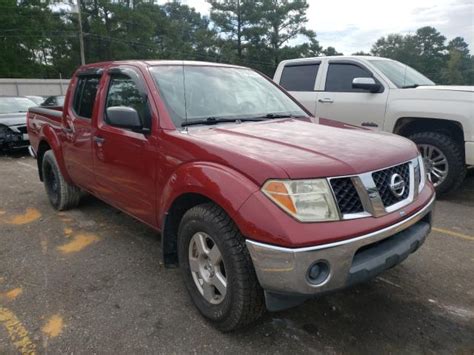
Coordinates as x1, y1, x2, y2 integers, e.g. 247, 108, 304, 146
246, 196, 435, 295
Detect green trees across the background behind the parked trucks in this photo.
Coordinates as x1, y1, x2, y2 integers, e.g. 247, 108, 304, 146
0, 0, 474, 85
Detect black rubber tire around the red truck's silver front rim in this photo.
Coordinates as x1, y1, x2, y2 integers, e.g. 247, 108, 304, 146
178, 203, 265, 332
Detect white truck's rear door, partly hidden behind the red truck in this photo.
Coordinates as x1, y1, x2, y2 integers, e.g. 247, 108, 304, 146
275, 60, 321, 115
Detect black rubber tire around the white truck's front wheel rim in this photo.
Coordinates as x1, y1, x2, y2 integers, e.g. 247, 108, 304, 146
408, 132, 467, 195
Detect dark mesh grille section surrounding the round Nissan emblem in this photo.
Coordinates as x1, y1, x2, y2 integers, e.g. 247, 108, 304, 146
372, 163, 410, 207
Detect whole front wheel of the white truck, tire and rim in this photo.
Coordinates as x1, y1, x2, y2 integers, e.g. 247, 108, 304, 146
409, 132, 466, 194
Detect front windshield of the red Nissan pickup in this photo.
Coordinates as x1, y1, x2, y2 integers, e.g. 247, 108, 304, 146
151, 65, 307, 127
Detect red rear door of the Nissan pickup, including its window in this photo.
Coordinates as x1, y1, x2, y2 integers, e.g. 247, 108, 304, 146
62, 70, 101, 191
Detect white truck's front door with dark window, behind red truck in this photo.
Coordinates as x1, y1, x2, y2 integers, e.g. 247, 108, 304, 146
316, 59, 389, 130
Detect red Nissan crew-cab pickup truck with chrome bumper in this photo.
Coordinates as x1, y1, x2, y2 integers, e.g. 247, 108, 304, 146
28, 61, 434, 331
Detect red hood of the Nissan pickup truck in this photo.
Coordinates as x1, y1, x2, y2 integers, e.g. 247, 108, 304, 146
185, 119, 418, 182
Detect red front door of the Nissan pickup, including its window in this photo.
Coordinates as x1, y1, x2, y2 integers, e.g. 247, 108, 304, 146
93, 66, 158, 225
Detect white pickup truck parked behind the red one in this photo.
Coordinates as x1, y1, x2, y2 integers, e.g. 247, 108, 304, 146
273, 56, 474, 193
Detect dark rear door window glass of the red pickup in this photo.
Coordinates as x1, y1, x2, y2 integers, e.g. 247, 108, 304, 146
72, 76, 100, 118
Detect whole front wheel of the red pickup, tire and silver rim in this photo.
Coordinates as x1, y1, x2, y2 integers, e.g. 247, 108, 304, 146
178, 203, 264, 331
